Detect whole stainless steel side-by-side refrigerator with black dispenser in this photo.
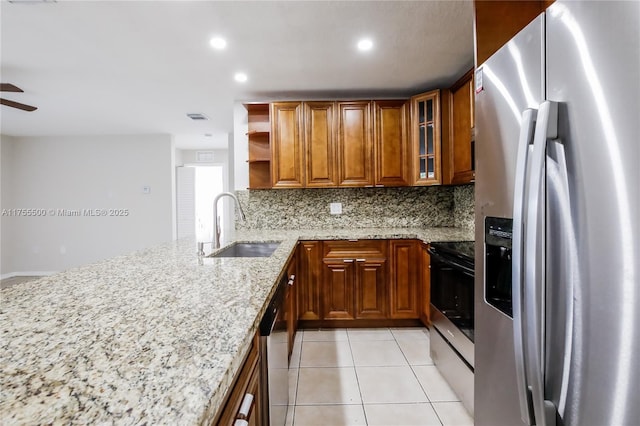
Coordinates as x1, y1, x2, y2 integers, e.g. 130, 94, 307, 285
474, 1, 640, 426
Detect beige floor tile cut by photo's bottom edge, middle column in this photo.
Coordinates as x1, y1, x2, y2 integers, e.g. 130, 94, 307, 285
364, 402, 441, 426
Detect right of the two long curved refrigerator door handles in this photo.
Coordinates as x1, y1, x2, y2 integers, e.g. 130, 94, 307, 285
523, 101, 558, 426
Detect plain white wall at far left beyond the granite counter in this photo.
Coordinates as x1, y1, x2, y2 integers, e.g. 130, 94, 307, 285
0, 135, 175, 276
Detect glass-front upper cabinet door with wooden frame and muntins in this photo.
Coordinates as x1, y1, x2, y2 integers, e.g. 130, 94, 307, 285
411, 90, 441, 185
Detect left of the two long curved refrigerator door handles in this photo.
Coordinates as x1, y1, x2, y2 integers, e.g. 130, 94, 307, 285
511, 109, 537, 425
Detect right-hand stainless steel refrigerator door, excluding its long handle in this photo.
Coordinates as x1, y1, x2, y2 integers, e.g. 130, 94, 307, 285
544, 0, 640, 425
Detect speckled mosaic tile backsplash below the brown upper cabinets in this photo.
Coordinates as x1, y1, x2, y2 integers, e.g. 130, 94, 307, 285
236, 186, 473, 230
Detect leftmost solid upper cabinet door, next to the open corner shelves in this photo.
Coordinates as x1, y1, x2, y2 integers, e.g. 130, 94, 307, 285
271, 102, 304, 188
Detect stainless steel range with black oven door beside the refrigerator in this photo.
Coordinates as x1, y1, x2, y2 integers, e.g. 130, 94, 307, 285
429, 241, 475, 414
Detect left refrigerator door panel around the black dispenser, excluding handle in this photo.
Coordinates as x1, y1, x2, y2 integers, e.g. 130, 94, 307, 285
474, 13, 544, 426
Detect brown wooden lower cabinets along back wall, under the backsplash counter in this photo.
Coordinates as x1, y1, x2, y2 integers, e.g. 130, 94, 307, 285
296, 240, 425, 327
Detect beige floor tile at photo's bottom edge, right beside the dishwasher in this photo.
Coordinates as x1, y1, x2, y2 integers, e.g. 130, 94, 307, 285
293, 405, 367, 426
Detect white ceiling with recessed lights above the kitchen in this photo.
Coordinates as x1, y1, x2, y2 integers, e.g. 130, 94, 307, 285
0, 0, 473, 148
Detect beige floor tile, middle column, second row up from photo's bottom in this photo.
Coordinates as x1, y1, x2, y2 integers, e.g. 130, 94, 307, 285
356, 366, 429, 404
